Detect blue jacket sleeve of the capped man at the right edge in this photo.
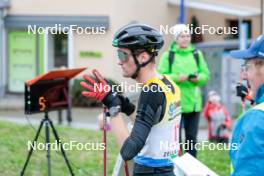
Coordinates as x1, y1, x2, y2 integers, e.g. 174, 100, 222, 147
232, 111, 264, 176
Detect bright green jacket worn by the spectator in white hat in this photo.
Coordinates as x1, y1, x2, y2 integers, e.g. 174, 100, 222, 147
158, 42, 209, 113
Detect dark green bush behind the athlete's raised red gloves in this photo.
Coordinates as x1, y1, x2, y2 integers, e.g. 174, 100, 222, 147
71, 78, 119, 107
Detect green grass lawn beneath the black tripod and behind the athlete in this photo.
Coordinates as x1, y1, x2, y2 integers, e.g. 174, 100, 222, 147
0, 121, 229, 176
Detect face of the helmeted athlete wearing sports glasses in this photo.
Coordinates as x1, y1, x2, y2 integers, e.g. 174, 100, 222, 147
117, 48, 137, 78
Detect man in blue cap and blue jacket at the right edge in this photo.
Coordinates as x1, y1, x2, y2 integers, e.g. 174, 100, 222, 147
230, 35, 264, 176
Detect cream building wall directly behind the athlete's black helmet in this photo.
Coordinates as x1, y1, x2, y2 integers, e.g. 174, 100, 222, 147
5, 0, 178, 80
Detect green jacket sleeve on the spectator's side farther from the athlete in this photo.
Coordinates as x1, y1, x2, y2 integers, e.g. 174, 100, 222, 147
195, 51, 210, 86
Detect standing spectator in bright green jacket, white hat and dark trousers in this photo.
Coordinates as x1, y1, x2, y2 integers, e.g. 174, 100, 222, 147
158, 24, 209, 157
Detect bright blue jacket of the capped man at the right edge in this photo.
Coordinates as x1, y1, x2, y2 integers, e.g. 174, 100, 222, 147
230, 84, 264, 176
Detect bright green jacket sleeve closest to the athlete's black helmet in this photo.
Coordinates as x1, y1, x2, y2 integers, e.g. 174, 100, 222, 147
157, 52, 182, 83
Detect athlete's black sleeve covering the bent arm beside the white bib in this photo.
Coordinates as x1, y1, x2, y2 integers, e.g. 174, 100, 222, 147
120, 85, 165, 161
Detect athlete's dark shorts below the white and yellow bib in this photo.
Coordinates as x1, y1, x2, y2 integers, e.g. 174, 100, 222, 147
133, 163, 175, 176
